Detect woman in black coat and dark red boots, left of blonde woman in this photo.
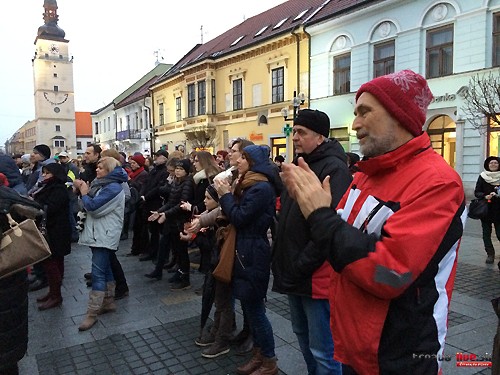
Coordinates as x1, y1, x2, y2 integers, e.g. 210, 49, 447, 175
33, 163, 71, 310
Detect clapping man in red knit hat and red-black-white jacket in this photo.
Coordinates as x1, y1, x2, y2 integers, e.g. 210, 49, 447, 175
282, 70, 466, 375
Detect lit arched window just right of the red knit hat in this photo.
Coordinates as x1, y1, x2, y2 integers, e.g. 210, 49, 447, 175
427, 115, 457, 168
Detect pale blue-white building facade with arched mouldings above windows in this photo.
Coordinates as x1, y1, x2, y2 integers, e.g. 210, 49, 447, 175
306, 0, 500, 195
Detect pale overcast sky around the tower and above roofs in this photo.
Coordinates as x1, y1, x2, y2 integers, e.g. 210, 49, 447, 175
0, 0, 285, 146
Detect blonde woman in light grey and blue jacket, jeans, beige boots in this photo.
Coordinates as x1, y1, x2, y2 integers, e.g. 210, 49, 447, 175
74, 157, 128, 331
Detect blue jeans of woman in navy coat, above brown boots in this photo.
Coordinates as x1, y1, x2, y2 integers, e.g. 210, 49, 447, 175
241, 299, 276, 358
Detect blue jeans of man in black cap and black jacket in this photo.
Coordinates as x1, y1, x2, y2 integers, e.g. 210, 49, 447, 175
288, 295, 342, 375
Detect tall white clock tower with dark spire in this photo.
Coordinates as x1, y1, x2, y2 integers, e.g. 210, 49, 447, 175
32, 0, 76, 157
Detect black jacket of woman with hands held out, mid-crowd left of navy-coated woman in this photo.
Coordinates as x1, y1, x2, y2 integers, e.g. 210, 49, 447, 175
158, 175, 194, 230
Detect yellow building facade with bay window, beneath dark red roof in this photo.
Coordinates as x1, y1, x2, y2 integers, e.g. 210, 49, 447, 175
150, 28, 309, 161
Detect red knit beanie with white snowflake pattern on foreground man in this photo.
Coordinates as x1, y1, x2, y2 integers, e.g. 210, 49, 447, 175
356, 70, 433, 136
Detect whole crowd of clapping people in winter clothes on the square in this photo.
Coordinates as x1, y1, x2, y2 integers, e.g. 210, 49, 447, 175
0, 70, 470, 375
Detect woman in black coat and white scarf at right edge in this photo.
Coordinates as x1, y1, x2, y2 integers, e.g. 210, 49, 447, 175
474, 156, 500, 264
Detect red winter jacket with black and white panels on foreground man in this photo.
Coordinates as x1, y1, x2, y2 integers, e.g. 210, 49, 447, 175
308, 133, 466, 375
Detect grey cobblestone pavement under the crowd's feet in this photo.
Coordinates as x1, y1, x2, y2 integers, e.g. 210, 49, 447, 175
20, 220, 500, 375
